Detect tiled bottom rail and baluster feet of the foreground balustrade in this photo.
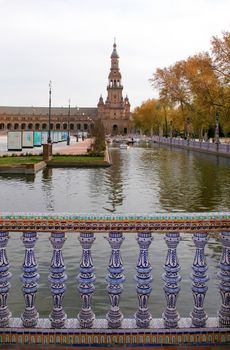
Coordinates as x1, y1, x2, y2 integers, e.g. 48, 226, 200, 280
0, 318, 230, 346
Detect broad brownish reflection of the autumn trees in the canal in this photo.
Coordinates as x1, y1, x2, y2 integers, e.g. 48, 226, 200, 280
158, 149, 230, 211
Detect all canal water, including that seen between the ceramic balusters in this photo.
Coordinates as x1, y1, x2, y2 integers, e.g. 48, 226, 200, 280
0, 145, 230, 317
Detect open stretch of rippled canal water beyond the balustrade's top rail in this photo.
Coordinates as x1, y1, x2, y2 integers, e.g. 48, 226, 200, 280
0, 145, 230, 213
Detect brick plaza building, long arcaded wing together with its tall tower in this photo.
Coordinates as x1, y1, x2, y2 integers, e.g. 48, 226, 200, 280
0, 43, 131, 135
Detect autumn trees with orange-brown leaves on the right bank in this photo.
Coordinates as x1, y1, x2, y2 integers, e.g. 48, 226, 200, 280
146, 32, 230, 137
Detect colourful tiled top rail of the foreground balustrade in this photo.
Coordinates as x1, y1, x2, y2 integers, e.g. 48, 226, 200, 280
0, 212, 230, 233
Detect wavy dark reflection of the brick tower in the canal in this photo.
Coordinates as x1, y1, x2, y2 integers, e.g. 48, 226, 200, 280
104, 150, 124, 212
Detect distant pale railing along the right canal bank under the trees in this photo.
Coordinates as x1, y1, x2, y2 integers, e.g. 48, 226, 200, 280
152, 136, 230, 156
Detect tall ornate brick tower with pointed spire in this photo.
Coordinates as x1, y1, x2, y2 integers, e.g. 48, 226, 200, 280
98, 41, 130, 135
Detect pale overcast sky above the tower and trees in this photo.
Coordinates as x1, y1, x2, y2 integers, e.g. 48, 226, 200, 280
0, 0, 230, 108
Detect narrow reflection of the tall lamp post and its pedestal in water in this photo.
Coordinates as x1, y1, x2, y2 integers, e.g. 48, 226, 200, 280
42, 167, 54, 211
